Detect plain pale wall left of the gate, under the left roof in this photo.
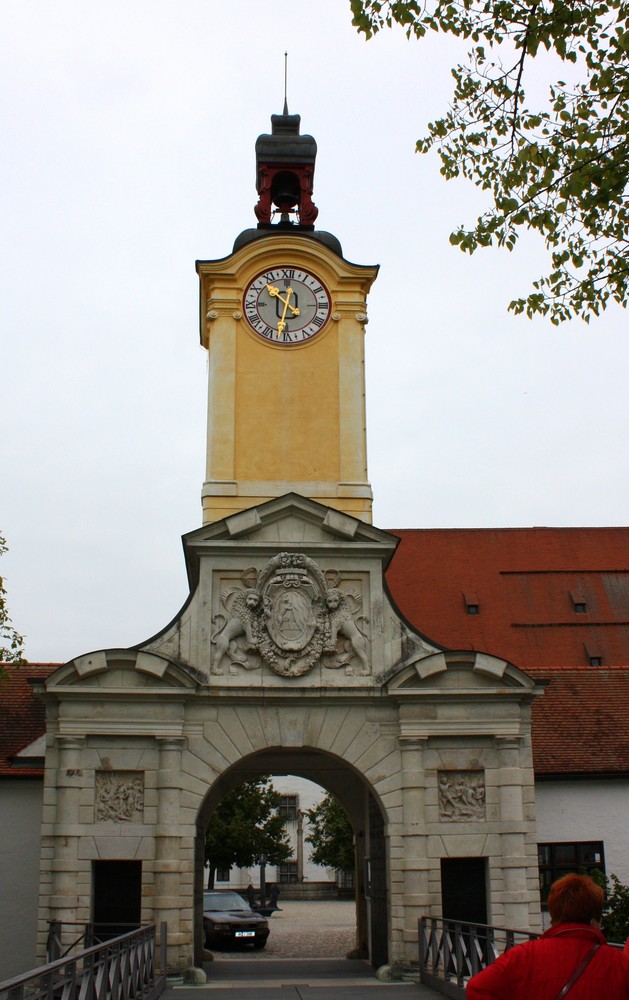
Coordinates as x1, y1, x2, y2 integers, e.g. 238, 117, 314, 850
0, 778, 42, 980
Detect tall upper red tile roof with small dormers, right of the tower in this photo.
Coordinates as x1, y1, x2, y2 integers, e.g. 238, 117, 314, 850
387, 528, 629, 671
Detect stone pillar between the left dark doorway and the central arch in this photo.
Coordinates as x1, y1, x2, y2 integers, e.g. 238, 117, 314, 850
154, 737, 192, 972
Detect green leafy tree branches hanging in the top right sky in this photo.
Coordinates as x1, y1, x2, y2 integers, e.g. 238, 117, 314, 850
350, 0, 629, 324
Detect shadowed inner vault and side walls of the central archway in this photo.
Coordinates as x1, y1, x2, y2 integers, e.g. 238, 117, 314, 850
194, 747, 389, 966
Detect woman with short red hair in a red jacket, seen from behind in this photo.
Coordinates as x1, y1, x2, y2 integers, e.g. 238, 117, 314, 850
465, 875, 629, 1000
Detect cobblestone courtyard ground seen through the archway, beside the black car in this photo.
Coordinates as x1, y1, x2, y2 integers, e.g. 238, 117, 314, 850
209, 899, 356, 961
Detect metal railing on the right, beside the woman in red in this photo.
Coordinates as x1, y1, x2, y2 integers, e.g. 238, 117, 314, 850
418, 917, 539, 1000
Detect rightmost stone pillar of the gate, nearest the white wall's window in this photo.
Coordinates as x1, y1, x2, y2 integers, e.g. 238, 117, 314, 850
496, 737, 529, 929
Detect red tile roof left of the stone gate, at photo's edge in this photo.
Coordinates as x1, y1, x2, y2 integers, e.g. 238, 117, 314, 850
0, 663, 59, 779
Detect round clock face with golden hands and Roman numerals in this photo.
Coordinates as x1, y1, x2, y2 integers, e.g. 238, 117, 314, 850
244, 267, 331, 346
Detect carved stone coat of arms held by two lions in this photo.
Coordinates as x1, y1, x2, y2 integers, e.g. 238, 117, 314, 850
211, 552, 370, 677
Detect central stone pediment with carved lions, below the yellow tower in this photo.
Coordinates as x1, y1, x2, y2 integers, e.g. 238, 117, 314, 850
142, 493, 422, 692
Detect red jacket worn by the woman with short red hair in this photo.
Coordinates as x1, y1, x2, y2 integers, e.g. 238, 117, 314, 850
465, 924, 629, 1000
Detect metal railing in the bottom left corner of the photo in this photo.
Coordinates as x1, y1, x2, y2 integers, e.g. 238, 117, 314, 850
0, 923, 166, 1000
